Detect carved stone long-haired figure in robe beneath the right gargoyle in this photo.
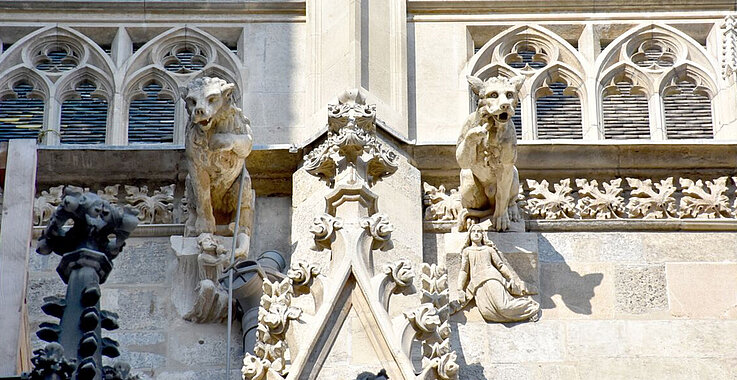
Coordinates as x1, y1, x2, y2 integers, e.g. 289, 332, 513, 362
458, 224, 540, 322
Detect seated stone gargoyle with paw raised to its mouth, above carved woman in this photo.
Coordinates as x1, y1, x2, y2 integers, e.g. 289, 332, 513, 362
456, 76, 525, 231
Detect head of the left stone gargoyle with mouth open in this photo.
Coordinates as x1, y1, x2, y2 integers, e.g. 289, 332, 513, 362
180, 77, 235, 131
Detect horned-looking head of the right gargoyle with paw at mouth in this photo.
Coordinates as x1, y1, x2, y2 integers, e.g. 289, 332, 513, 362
466, 75, 525, 123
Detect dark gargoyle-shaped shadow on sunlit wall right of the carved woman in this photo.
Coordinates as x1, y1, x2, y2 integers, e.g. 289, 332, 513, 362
538, 235, 604, 318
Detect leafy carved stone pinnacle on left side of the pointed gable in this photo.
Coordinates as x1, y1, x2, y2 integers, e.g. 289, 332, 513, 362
247, 278, 302, 379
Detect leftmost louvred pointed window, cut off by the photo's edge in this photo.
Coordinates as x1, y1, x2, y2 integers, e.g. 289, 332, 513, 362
0, 79, 44, 141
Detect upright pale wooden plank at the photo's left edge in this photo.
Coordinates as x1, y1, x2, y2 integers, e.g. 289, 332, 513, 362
0, 139, 36, 376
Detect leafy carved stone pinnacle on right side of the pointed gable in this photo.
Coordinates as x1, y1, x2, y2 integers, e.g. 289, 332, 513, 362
404, 263, 459, 380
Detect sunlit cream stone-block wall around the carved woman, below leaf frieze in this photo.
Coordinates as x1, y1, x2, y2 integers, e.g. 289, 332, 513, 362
425, 232, 737, 379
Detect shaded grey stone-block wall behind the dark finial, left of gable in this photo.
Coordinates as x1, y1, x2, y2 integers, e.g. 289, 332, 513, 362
27, 197, 289, 380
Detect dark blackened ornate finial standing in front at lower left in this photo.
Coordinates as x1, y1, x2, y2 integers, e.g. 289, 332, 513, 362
25, 189, 138, 380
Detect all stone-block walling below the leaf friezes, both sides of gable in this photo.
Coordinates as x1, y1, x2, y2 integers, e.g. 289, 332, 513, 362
27, 226, 737, 380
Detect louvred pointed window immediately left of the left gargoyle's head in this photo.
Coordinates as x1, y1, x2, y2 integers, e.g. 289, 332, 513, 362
128, 80, 176, 144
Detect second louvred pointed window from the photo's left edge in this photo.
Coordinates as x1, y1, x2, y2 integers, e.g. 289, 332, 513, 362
60, 79, 108, 144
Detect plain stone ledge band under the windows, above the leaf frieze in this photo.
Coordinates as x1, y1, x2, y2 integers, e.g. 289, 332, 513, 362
23, 140, 737, 195
